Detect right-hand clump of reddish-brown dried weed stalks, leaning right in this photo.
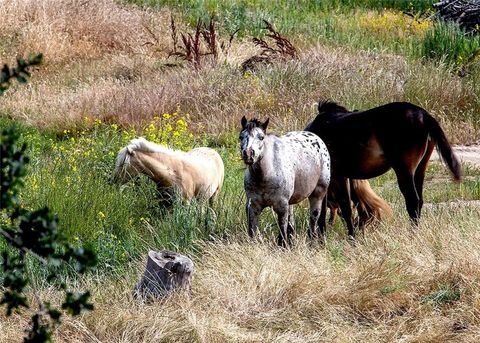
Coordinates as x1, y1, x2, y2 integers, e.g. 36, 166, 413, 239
242, 20, 298, 72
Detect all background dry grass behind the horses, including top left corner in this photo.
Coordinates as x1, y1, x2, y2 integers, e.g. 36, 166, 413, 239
0, 0, 480, 143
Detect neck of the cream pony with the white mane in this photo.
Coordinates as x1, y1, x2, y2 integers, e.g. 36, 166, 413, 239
137, 151, 181, 186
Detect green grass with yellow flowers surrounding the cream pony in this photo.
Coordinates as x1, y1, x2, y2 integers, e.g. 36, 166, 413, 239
0, 113, 244, 272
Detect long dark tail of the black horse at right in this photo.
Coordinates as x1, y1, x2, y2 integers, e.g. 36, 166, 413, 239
424, 112, 462, 181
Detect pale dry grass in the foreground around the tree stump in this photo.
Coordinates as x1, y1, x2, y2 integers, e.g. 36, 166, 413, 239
0, 204, 480, 342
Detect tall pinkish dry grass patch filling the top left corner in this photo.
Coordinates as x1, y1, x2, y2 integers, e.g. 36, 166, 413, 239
0, 0, 172, 63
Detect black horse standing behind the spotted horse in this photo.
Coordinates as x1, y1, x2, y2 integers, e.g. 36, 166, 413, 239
305, 101, 462, 237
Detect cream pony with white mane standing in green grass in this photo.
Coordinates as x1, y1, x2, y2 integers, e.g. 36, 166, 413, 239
114, 138, 224, 204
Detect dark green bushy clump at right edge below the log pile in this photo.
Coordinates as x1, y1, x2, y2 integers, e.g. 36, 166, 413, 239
422, 22, 480, 69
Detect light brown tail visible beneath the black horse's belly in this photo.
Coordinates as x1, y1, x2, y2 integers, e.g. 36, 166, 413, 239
350, 179, 393, 221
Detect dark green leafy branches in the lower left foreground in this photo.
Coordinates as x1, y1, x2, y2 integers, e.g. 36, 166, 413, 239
0, 126, 97, 342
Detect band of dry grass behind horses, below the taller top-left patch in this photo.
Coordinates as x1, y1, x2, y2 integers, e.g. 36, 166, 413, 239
1, 43, 480, 143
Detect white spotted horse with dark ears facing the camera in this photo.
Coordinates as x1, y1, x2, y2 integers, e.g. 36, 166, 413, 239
240, 117, 330, 247
